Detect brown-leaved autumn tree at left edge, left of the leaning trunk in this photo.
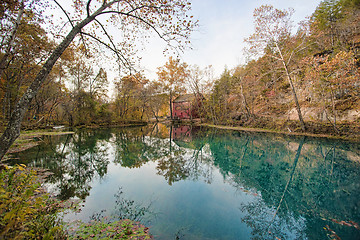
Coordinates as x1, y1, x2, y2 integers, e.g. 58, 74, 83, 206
0, 1, 52, 127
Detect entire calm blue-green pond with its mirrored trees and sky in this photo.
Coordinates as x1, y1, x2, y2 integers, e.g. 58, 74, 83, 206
11, 125, 360, 240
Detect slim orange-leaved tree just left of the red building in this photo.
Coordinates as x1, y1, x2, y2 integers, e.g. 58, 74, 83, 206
157, 57, 188, 119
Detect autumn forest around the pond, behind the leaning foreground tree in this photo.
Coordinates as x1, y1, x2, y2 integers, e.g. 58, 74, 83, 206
0, 0, 360, 147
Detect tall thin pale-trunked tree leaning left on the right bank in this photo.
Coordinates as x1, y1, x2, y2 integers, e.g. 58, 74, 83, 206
246, 5, 306, 131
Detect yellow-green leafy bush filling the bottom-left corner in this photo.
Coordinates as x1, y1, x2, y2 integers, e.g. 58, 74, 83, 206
0, 165, 64, 239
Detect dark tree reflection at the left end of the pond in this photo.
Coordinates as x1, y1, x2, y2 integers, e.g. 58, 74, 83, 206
12, 130, 111, 200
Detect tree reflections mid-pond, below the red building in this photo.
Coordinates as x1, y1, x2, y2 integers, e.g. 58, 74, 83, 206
114, 126, 211, 185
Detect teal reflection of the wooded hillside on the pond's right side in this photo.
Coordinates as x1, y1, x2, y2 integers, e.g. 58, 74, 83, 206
210, 133, 360, 239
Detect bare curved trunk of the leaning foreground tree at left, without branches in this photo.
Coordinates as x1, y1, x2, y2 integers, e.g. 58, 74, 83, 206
0, 12, 98, 160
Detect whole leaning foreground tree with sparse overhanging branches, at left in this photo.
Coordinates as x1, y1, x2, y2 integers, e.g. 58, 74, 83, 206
0, 0, 197, 159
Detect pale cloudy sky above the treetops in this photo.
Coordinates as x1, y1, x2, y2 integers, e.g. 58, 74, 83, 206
139, 0, 321, 79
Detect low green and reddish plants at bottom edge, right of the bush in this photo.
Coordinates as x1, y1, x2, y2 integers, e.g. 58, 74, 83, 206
69, 219, 152, 239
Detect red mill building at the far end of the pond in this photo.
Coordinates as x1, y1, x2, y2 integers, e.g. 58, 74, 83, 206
172, 94, 204, 119
